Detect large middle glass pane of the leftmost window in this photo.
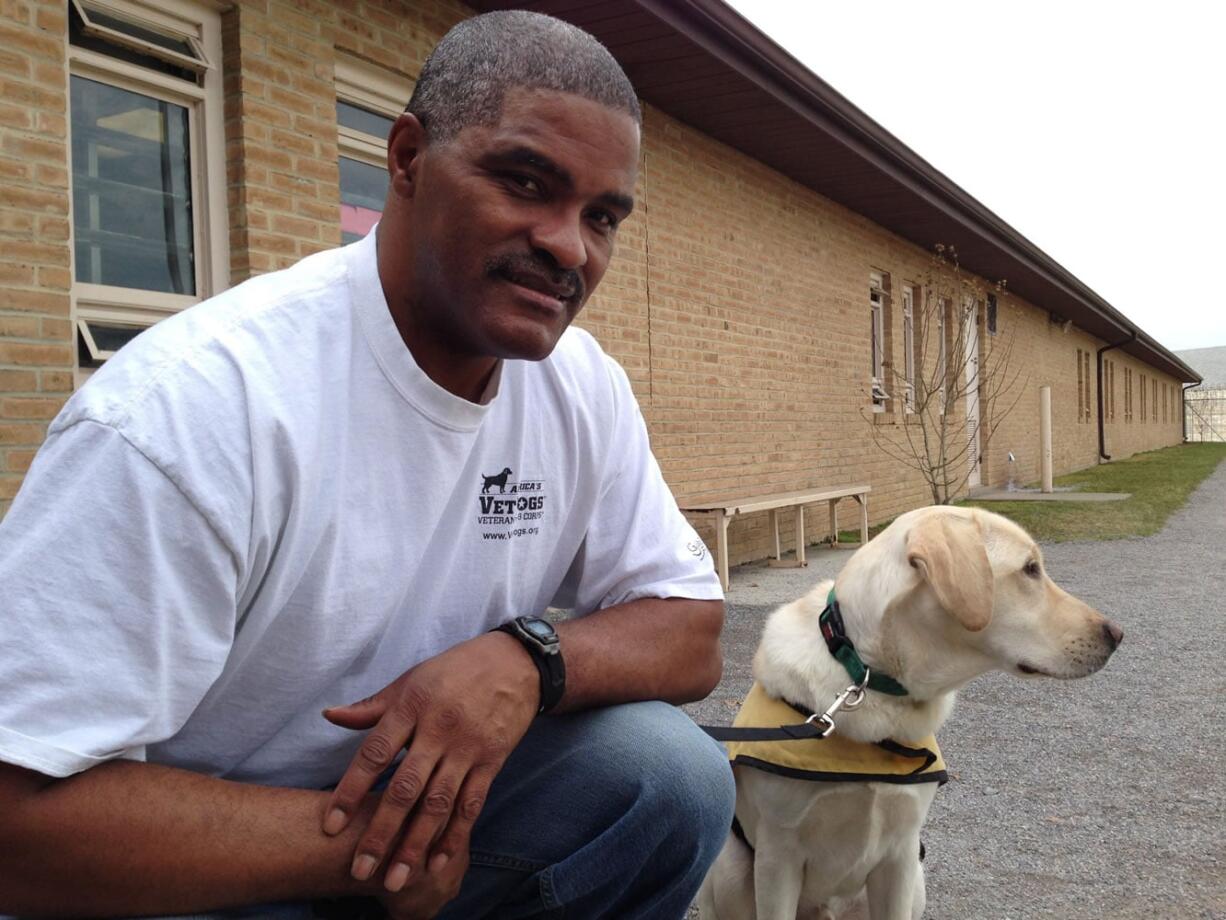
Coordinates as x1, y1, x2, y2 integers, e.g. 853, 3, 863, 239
71, 76, 196, 294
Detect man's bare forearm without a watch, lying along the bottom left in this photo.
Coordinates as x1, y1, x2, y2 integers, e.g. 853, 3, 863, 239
0, 761, 375, 916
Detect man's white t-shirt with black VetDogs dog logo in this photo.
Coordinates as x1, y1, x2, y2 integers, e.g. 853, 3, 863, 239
0, 233, 721, 788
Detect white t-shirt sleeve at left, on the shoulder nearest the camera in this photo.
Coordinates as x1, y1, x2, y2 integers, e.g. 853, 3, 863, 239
0, 421, 238, 776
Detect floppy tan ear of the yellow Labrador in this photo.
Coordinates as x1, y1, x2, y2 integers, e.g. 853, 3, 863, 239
907, 514, 993, 632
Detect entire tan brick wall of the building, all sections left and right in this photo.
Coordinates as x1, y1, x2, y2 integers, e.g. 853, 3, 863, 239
0, 0, 1179, 547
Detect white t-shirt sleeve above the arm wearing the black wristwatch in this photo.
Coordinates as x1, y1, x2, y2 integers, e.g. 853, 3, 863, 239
554, 358, 723, 613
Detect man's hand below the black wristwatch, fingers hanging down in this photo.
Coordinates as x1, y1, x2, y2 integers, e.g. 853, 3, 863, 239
324, 633, 541, 897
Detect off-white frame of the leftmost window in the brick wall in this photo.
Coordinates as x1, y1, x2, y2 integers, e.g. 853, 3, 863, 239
65, 0, 229, 383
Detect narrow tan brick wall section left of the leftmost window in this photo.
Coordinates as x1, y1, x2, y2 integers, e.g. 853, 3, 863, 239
0, 0, 74, 514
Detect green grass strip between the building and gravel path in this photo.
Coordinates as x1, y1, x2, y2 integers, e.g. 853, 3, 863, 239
960, 443, 1226, 542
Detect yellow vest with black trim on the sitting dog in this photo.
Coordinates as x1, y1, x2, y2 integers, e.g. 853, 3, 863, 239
727, 681, 949, 783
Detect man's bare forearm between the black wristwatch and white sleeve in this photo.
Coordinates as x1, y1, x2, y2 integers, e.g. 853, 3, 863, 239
558, 597, 723, 711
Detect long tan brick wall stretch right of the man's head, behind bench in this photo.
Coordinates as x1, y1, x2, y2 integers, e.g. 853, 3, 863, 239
598, 107, 1181, 569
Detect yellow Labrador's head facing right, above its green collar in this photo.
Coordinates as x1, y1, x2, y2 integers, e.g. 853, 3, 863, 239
839, 507, 1123, 680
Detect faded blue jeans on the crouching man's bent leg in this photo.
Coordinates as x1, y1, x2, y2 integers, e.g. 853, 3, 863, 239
176, 703, 734, 920
